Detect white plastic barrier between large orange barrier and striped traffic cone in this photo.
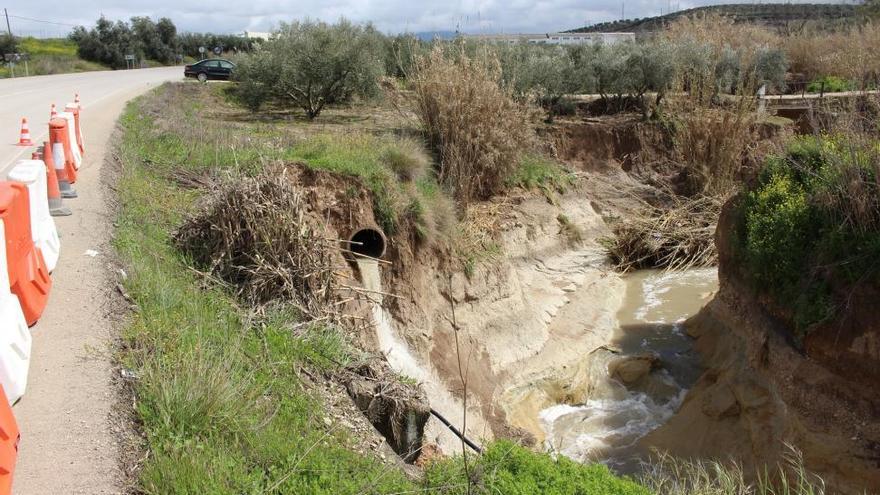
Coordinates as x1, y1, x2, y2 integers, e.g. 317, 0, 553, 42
6, 160, 61, 273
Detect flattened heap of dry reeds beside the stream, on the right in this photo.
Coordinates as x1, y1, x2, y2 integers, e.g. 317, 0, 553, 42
605, 194, 724, 272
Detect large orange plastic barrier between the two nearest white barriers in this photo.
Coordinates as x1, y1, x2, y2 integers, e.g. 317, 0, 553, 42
0, 181, 52, 326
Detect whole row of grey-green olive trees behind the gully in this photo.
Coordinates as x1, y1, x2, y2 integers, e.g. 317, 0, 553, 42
236, 20, 788, 118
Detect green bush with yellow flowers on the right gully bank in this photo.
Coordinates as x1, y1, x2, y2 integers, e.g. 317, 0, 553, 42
740, 136, 880, 337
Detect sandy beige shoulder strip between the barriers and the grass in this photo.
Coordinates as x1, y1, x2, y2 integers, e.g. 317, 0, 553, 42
8, 77, 171, 495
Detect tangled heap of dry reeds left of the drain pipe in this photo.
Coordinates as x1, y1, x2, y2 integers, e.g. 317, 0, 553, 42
175, 167, 336, 320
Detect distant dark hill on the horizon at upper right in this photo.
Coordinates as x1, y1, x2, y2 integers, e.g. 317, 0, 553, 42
568, 3, 856, 34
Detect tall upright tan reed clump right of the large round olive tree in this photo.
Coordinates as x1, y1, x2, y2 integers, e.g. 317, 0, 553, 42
411, 47, 534, 204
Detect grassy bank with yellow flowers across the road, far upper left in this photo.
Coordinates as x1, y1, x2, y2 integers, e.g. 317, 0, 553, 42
0, 38, 107, 77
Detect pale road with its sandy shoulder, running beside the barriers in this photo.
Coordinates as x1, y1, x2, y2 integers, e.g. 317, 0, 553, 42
0, 67, 182, 495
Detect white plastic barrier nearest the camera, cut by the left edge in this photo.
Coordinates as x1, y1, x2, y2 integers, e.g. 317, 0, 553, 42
0, 220, 31, 406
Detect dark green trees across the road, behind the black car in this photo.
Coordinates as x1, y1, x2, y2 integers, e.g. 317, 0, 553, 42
70, 16, 253, 69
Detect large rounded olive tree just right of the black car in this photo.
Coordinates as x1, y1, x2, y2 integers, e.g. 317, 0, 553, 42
236, 19, 384, 119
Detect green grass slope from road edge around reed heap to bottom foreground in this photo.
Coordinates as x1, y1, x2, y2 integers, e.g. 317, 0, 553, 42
114, 80, 648, 495
